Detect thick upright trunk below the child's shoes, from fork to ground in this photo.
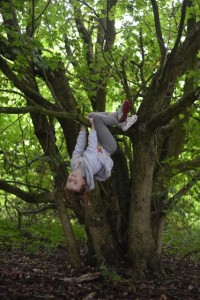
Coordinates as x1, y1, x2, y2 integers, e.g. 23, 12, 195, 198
129, 129, 161, 274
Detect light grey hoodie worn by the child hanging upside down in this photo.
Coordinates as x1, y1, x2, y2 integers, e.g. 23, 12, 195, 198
70, 129, 113, 190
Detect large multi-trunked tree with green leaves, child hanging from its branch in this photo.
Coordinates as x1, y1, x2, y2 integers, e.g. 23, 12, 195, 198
0, 0, 200, 274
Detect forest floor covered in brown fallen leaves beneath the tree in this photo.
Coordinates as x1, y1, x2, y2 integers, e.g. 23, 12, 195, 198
0, 246, 200, 300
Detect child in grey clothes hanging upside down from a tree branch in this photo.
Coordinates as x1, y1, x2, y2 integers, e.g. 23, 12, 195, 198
65, 100, 138, 193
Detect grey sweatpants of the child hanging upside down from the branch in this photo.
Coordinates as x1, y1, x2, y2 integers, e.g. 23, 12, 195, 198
88, 112, 120, 154
